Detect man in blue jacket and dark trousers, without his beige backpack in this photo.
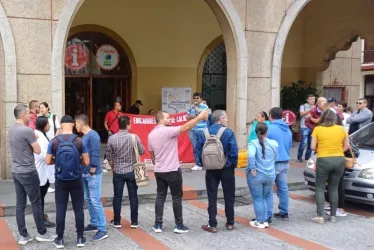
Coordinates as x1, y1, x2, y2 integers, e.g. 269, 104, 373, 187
196, 110, 238, 233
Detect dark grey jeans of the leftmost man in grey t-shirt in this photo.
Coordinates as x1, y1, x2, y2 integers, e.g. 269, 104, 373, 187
12, 170, 47, 237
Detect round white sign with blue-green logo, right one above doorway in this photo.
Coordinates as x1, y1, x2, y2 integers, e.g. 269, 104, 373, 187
96, 44, 119, 70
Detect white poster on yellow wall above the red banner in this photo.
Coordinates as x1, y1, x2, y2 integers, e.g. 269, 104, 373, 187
162, 88, 192, 114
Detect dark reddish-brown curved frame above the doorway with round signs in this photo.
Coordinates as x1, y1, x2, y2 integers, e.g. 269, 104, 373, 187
67, 24, 137, 98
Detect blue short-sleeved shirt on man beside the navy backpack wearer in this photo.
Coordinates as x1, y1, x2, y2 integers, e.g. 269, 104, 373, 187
82, 130, 103, 174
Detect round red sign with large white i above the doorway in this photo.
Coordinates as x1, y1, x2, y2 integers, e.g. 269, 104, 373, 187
65, 43, 89, 71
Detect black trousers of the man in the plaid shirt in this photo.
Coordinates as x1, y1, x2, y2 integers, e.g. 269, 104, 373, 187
113, 171, 139, 223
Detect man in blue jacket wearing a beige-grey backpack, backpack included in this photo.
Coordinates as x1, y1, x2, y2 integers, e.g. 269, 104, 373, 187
197, 110, 238, 233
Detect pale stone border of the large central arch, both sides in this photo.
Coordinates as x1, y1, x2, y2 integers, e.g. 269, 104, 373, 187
51, 0, 248, 147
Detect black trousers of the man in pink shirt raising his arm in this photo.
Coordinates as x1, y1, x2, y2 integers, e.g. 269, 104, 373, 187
155, 169, 183, 225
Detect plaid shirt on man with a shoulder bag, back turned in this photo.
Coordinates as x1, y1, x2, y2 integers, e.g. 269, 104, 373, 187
106, 130, 145, 174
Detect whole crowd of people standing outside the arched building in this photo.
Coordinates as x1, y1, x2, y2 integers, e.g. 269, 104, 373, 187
9, 93, 372, 248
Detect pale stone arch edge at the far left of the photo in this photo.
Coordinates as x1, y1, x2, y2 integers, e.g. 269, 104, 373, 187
0, 0, 18, 179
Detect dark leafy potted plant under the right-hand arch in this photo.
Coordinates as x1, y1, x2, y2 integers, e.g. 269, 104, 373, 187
281, 80, 320, 142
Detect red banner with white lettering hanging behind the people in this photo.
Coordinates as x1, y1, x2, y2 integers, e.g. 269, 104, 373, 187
126, 112, 195, 163
